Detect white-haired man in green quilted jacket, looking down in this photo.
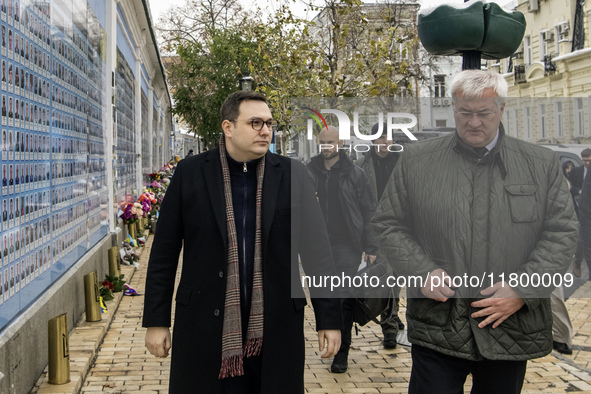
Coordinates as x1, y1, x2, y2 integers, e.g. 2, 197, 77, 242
372, 70, 577, 393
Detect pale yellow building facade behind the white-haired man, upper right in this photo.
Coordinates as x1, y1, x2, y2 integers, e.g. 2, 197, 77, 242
487, 0, 591, 144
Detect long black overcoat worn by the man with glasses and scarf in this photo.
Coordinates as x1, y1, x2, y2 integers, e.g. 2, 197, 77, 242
143, 149, 342, 394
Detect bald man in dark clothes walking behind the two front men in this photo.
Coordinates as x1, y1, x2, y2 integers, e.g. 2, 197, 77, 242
308, 126, 377, 373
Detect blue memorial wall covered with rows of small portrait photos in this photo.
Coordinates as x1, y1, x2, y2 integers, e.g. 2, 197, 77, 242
0, 0, 171, 336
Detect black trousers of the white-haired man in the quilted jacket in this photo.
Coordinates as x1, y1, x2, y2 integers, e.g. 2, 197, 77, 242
408, 344, 527, 394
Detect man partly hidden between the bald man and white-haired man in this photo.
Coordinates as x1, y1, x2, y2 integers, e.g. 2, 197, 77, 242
355, 123, 404, 349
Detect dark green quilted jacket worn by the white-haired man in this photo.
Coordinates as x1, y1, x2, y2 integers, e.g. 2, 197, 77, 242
372, 126, 577, 360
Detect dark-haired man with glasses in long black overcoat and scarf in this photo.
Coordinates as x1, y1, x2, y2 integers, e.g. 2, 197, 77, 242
143, 91, 342, 394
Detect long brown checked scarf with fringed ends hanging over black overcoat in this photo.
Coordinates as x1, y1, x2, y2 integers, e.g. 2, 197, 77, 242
219, 136, 265, 379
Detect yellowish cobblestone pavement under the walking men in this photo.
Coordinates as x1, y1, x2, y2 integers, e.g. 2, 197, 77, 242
81, 235, 591, 394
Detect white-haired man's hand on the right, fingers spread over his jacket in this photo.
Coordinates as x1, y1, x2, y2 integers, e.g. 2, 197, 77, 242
471, 282, 525, 328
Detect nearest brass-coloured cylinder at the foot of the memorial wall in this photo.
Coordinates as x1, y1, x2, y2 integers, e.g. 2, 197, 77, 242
47, 313, 70, 384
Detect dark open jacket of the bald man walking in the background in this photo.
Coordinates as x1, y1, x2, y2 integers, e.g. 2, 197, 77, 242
308, 151, 377, 255
